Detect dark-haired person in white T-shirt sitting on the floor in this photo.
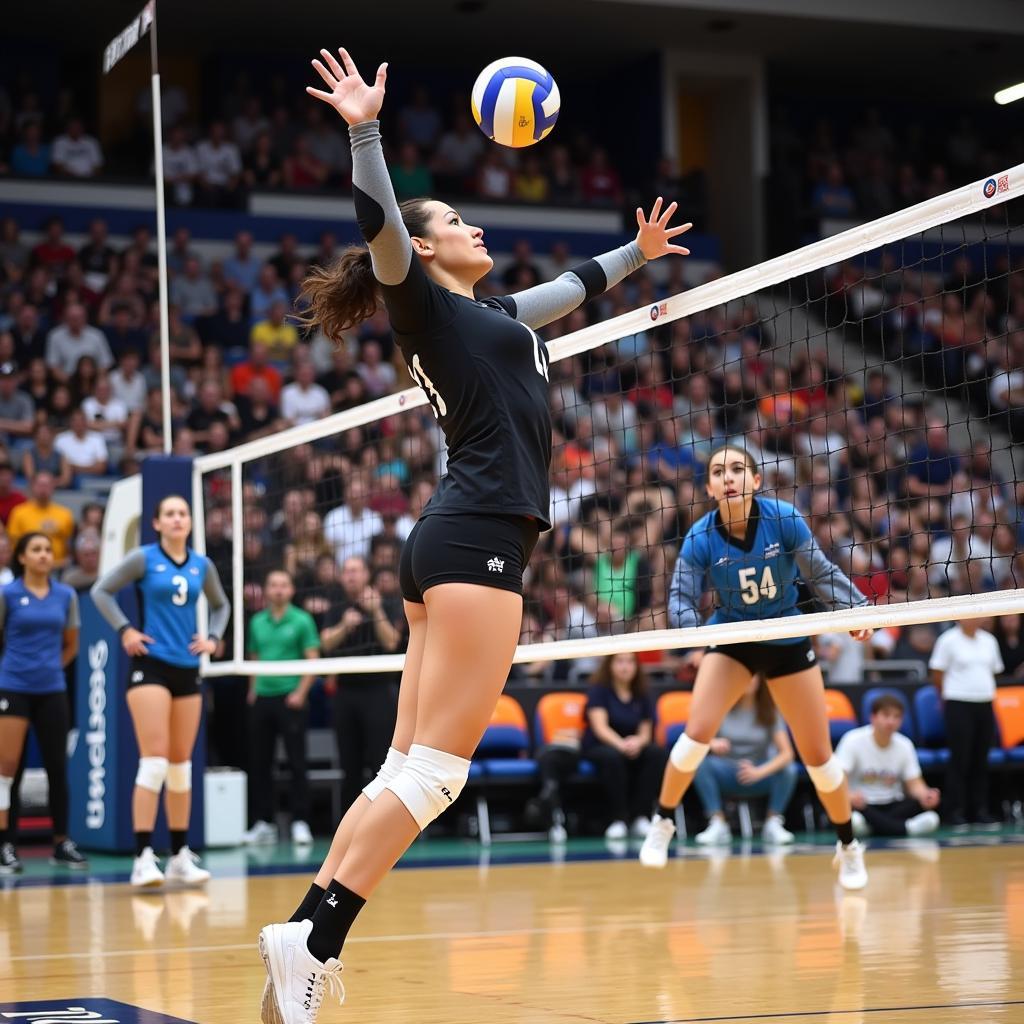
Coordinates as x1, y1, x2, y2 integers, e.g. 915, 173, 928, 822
836, 693, 940, 836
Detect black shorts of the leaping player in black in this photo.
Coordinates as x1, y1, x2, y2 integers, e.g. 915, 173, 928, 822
398, 514, 540, 604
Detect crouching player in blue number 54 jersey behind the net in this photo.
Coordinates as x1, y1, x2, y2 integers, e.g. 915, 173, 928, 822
640, 446, 871, 889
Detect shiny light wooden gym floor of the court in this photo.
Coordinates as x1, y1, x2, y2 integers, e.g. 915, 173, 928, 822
0, 833, 1024, 1024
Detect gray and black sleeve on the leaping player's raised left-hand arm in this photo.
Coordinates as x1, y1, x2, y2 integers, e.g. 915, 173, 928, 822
348, 121, 413, 285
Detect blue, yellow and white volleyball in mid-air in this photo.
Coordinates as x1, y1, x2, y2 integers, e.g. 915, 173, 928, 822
472, 57, 561, 150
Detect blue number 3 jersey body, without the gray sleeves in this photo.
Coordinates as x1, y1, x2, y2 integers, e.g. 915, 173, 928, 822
135, 544, 208, 669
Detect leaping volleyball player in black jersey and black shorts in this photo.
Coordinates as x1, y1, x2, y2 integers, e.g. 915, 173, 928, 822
260, 49, 690, 1024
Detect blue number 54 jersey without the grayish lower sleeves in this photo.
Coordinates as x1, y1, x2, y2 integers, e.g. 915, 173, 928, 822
679, 498, 812, 643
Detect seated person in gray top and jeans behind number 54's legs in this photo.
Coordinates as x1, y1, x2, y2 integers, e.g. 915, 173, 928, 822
693, 676, 797, 846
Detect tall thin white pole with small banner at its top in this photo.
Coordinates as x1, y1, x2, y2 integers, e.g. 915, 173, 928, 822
103, 0, 172, 455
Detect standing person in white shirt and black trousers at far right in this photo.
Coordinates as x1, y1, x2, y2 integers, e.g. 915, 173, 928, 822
928, 618, 1004, 828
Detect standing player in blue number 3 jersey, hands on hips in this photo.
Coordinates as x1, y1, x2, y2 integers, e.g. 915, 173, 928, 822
91, 495, 230, 888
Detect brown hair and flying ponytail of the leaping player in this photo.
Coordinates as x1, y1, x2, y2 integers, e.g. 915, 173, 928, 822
298, 198, 431, 341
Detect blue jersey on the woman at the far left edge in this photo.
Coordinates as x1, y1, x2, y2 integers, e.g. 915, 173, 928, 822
0, 580, 79, 693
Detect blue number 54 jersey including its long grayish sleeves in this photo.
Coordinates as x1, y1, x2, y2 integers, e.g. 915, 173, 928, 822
669, 498, 867, 643
